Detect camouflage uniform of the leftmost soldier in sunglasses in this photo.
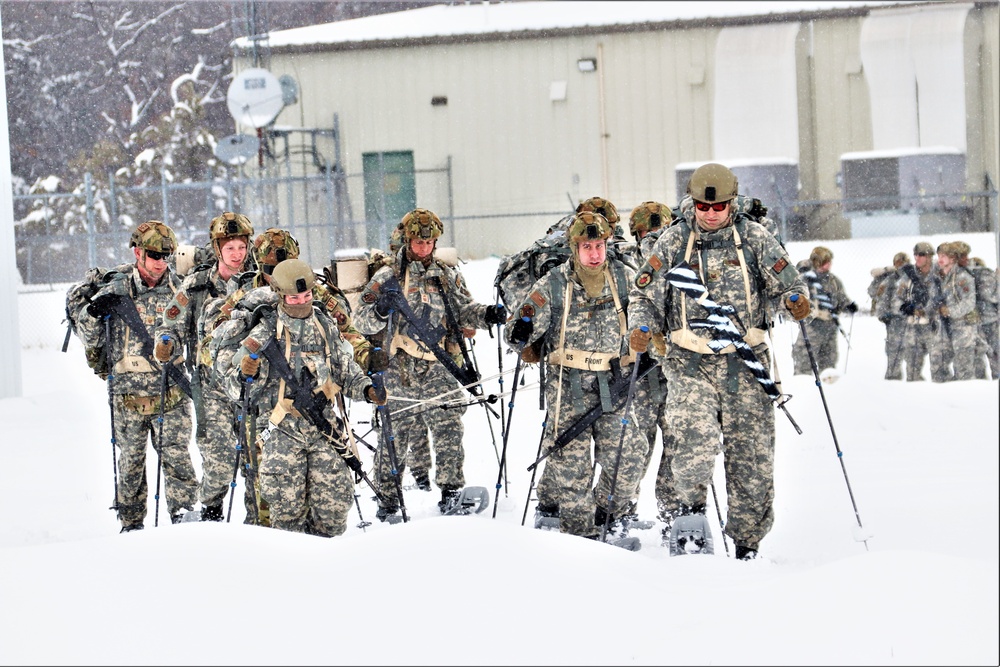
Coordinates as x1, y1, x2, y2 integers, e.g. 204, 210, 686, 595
79, 264, 198, 529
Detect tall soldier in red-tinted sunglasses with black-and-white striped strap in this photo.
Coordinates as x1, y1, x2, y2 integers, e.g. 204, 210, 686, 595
628, 163, 809, 559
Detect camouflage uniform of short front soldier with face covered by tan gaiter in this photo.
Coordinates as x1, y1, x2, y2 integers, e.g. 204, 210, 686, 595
224, 298, 371, 537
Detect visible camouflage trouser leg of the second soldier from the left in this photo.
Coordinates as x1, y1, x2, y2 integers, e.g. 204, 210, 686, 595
196, 377, 245, 507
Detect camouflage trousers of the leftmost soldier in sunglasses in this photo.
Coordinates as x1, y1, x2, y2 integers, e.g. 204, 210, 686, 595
113, 395, 198, 526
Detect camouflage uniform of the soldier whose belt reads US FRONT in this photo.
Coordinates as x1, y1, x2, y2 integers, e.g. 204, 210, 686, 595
504, 214, 648, 537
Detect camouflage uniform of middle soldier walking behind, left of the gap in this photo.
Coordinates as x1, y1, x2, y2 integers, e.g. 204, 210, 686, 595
354, 240, 490, 514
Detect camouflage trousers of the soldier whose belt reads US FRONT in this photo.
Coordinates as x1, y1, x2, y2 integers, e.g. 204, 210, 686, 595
537, 364, 649, 537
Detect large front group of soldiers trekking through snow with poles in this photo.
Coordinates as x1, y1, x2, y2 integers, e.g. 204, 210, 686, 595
68, 163, 828, 559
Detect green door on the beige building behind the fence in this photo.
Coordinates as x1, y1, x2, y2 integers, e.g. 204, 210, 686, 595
362, 151, 417, 249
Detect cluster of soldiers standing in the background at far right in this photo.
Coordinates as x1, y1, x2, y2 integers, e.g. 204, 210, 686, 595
868, 241, 1000, 382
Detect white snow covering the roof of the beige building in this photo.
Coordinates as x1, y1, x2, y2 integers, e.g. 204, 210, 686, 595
240, 0, 922, 49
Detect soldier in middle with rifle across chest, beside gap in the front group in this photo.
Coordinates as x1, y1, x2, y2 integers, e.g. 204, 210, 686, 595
355, 208, 506, 522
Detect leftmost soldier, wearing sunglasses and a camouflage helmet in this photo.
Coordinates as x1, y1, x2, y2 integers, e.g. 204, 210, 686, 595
78, 220, 198, 533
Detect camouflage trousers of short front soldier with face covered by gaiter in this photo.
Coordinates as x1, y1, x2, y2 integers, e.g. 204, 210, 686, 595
257, 415, 354, 537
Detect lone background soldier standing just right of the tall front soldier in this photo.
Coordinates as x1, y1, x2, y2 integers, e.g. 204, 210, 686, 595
792, 246, 858, 375
